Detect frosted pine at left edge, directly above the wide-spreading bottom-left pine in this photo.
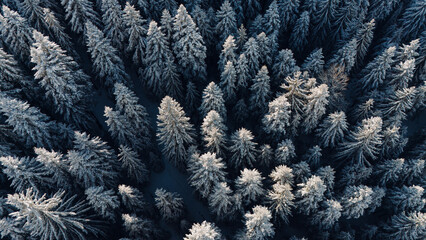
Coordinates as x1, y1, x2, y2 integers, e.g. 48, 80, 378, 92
0, 156, 50, 192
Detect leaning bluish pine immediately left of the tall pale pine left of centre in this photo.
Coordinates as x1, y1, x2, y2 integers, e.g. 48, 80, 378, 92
114, 83, 152, 147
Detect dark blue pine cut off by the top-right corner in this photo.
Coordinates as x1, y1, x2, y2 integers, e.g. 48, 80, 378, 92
401, 0, 426, 39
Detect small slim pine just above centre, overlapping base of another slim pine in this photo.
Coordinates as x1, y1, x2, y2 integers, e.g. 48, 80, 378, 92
219, 61, 237, 102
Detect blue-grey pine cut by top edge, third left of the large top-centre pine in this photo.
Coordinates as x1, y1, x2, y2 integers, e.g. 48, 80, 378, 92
101, 0, 126, 51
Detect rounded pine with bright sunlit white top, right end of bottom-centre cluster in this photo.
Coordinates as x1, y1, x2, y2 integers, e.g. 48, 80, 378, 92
296, 175, 327, 215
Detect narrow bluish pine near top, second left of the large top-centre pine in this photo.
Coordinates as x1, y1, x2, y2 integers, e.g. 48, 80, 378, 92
123, 3, 147, 65
